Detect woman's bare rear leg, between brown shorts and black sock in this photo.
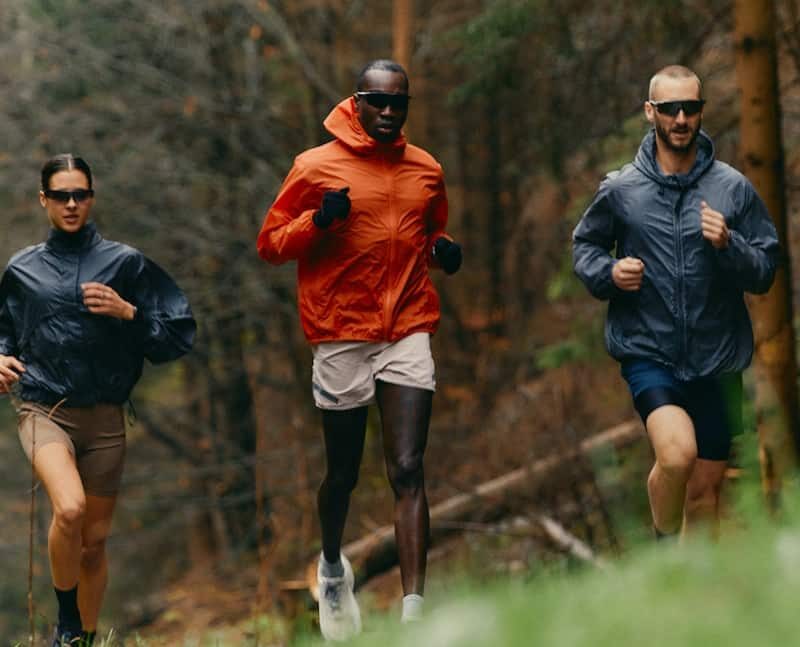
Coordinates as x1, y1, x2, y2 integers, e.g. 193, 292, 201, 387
78, 495, 117, 631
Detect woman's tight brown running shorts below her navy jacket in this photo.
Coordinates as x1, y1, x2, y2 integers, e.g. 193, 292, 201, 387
14, 400, 125, 496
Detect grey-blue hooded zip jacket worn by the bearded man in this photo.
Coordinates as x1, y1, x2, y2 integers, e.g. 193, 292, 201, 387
573, 131, 779, 380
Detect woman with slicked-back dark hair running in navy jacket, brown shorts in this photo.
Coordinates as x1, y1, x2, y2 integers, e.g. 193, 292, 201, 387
0, 155, 195, 647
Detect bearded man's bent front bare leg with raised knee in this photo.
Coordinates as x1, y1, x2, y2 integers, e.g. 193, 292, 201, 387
646, 405, 697, 533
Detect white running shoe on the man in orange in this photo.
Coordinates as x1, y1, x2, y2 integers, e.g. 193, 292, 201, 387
317, 555, 361, 641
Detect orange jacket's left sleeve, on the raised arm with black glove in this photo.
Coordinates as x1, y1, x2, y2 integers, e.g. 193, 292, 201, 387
257, 160, 324, 265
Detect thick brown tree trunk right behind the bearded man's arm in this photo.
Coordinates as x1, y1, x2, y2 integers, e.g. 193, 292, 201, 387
734, 0, 798, 501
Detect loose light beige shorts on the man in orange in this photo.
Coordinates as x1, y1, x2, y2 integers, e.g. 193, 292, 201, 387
311, 332, 436, 410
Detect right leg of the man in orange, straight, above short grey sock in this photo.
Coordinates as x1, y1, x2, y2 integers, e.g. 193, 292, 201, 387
376, 381, 433, 595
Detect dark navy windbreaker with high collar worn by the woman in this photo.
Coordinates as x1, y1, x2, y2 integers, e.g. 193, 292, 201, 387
0, 222, 196, 406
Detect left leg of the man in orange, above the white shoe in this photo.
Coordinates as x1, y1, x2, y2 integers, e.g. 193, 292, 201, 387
317, 407, 367, 563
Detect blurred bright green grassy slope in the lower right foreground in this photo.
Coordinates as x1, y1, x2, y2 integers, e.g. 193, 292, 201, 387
297, 526, 800, 647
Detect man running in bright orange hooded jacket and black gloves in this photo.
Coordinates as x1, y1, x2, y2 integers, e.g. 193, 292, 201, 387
258, 60, 461, 640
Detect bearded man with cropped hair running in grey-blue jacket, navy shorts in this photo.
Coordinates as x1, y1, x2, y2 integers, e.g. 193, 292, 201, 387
573, 66, 779, 536
